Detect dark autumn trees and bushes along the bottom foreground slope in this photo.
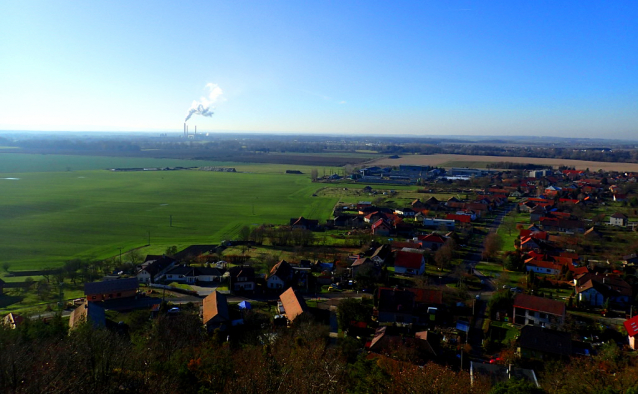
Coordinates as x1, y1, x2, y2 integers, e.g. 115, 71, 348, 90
0, 307, 638, 394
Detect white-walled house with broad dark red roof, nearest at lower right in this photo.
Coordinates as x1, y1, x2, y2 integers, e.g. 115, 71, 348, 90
513, 294, 566, 328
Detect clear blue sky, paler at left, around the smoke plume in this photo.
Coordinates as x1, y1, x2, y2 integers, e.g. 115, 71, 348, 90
0, 0, 638, 138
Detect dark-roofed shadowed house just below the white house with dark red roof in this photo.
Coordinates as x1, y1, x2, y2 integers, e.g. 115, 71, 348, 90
518, 325, 572, 360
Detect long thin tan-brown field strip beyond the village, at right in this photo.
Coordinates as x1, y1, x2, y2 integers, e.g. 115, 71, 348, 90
369, 154, 638, 172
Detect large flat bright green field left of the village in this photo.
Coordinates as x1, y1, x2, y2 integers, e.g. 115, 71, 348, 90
0, 154, 337, 271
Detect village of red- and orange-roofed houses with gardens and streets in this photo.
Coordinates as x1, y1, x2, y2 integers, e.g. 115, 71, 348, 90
0, 165, 638, 388
